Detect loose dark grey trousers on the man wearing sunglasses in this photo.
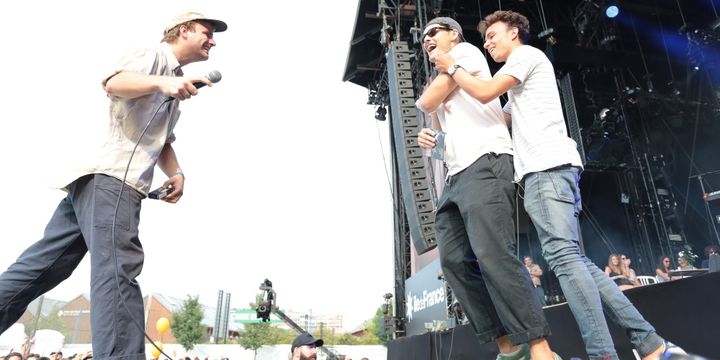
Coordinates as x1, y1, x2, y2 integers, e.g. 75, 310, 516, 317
435, 154, 550, 344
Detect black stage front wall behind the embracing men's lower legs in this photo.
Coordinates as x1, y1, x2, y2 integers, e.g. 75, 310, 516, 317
388, 272, 720, 360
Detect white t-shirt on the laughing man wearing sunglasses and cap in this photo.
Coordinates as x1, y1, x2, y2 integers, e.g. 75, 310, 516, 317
430, 42, 513, 176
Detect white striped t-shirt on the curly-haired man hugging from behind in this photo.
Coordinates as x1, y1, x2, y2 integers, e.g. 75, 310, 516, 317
496, 45, 582, 181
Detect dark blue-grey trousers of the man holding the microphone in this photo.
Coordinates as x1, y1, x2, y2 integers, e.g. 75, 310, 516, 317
0, 174, 145, 360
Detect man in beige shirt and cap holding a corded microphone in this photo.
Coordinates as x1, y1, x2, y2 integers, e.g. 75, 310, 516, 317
0, 12, 227, 360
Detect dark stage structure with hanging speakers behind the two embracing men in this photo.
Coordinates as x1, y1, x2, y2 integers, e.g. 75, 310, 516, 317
343, 0, 720, 358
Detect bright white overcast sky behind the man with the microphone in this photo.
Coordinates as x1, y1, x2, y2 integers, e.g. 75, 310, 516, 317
0, 0, 393, 330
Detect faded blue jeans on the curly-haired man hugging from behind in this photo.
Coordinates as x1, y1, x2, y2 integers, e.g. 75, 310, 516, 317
523, 167, 663, 359
